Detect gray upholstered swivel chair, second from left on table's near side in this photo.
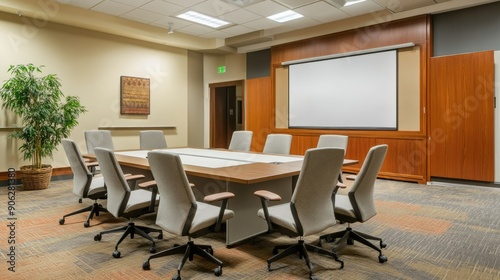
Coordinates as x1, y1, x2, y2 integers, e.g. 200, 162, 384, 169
94, 147, 163, 258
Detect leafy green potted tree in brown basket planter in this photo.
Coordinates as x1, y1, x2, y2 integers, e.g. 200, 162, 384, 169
0, 63, 86, 190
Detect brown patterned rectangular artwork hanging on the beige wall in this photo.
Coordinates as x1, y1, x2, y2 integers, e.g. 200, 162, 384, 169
120, 76, 150, 115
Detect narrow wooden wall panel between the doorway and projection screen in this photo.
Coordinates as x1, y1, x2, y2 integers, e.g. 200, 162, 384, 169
246, 77, 274, 152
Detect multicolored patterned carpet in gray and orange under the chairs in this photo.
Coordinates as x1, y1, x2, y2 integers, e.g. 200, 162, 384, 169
0, 180, 500, 279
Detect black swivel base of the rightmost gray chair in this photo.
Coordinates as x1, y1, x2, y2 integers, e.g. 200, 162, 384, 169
319, 227, 387, 263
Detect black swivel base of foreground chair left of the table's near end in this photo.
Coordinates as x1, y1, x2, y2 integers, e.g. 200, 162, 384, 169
142, 238, 222, 280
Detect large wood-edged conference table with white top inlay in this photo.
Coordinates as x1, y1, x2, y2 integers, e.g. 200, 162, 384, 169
85, 148, 358, 246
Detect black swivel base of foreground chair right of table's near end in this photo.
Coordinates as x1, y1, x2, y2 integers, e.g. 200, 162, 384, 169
267, 240, 344, 280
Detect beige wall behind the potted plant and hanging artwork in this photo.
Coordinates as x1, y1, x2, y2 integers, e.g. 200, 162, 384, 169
0, 13, 188, 171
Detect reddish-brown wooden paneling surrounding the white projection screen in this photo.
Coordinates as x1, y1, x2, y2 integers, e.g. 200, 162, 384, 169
246, 16, 430, 183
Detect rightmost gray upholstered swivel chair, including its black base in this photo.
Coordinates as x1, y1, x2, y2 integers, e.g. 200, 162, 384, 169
320, 145, 387, 263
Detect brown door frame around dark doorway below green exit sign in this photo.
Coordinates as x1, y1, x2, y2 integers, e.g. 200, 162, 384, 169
208, 80, 246, 148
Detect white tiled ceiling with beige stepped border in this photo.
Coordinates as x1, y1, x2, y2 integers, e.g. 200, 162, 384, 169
0, 0, 496, 52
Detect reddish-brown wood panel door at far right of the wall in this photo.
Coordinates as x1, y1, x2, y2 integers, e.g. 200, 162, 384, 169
428, 51, 495, 182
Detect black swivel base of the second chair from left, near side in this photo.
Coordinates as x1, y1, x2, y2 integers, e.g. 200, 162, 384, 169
94, 222, 163, 258
